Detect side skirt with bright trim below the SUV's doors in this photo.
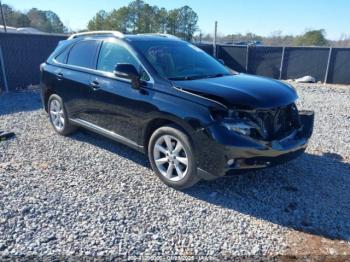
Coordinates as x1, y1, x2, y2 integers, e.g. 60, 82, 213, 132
69, 118, 144, 153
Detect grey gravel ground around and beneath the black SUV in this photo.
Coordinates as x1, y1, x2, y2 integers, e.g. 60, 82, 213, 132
0, 85, 350, 259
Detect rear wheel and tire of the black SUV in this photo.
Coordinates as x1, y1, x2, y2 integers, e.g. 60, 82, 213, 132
47, 95, 77, 136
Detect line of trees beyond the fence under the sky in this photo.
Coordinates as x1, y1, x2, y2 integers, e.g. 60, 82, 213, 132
0, 0, 350, 47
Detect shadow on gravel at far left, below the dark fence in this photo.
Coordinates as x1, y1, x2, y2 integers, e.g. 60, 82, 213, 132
0, 90, 42, 115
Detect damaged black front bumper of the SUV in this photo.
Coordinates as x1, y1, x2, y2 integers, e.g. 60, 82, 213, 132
196, 111, 314, 180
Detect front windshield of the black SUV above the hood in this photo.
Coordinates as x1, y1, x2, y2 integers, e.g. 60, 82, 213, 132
134, 41, 231, 80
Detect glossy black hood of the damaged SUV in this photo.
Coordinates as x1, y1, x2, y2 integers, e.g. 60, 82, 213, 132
173, 74, 298, 108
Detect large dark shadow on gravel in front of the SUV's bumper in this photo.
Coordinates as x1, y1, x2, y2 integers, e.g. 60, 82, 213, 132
185, 153, 350, 241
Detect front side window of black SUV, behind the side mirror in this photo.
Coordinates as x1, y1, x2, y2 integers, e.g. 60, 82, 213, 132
97, 42, 149, 81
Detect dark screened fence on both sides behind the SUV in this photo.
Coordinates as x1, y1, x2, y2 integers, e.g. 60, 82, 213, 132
0, 33, 350, 91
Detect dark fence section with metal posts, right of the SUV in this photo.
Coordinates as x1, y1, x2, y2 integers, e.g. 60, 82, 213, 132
198, 44, 350, 84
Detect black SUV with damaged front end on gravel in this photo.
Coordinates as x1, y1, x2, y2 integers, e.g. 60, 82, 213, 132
41, 31, 314, 189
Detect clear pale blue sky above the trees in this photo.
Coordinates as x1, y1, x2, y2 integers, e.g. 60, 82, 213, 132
2, 0, 350, 40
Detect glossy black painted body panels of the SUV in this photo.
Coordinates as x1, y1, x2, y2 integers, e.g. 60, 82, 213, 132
41, 33, 313, 179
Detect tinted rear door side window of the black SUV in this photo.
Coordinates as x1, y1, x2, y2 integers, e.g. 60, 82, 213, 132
67, 40, 98, 68
